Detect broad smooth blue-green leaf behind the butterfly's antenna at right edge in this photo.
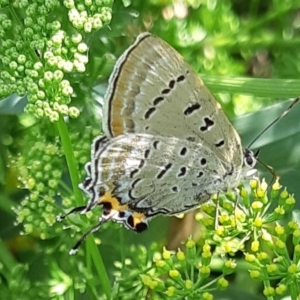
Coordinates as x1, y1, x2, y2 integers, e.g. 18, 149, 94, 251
233, 100, 300, 208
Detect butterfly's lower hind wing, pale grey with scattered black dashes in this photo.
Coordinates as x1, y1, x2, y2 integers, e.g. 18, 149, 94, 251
82, 134, 238, 217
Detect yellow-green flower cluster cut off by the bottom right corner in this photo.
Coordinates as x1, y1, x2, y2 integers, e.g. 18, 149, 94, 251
245, 221, 300, 299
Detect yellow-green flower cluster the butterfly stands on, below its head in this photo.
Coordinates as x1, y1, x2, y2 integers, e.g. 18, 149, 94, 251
196, 180, 295, 253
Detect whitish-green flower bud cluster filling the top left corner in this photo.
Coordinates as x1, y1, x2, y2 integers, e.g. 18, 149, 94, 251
0, 0, 112, 122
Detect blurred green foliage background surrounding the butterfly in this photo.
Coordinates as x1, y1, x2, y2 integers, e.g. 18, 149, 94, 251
0, 0, 300, 299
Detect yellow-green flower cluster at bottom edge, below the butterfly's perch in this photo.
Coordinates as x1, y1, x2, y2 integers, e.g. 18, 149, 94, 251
140, 239, 236, 299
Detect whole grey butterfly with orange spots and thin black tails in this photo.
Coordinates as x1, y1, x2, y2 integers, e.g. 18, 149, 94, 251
59, 33, 258, 254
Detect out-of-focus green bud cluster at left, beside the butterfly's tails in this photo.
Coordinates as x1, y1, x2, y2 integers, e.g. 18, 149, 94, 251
13, 124, 99, 246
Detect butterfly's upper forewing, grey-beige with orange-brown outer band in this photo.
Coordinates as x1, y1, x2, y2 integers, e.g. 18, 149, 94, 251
103, 33, 243, 167
